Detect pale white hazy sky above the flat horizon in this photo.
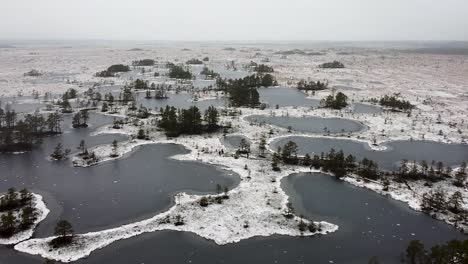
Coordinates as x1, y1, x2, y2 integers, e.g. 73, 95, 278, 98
0, 0, 468, 41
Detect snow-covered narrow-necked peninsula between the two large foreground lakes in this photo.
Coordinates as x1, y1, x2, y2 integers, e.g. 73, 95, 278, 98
15, 131, 338, 262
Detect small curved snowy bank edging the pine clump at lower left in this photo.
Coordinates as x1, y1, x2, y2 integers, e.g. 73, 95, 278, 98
0, 193, 50, 245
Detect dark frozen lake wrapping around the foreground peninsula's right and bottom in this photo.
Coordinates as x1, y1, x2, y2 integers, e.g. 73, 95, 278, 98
0, 173, 467, 264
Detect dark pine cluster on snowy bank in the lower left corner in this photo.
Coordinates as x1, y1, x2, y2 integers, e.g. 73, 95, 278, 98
0, 188, 37, 238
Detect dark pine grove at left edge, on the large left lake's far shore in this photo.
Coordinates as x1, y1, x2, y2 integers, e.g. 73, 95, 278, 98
0, 108, 63, 152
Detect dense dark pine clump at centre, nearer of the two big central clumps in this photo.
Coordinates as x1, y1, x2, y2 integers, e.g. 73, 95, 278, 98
158, 106, 220, 137
